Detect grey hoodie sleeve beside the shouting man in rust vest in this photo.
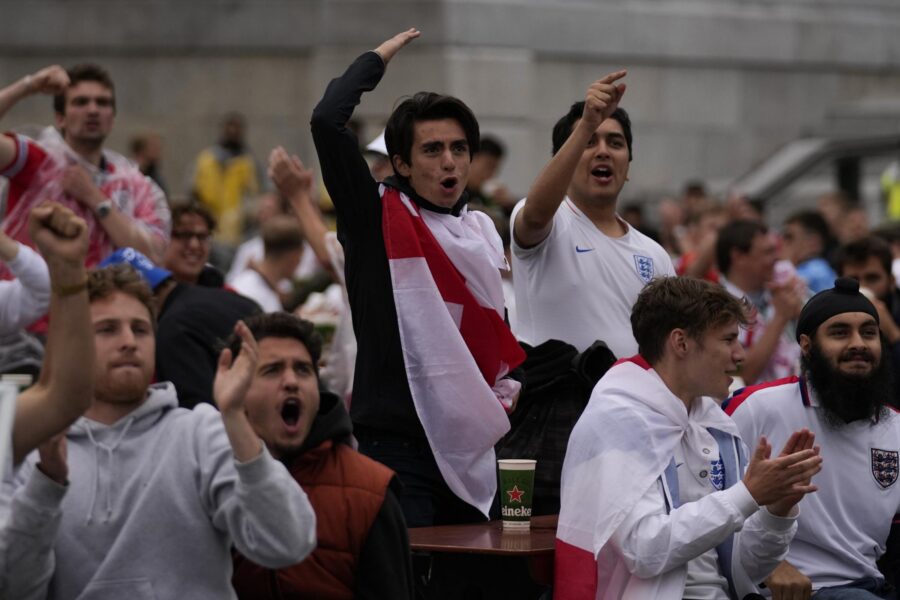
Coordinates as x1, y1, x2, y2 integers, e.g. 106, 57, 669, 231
194, 405, 316, 569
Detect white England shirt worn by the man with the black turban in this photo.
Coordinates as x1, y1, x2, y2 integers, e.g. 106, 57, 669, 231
726, 377, 900, 590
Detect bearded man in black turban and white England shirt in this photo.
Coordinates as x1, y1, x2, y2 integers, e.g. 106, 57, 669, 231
725, 278, 900, 600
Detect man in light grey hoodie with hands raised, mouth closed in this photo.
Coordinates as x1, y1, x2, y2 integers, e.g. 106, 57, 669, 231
4, 265, 316, 600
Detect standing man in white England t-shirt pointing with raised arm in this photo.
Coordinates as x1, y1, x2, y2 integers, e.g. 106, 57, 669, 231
511, 71, 675, 356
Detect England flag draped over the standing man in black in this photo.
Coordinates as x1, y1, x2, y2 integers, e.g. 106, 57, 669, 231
379, 184, 525, 516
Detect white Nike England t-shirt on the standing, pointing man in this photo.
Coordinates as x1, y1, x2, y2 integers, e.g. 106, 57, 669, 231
511, 197, 675, 357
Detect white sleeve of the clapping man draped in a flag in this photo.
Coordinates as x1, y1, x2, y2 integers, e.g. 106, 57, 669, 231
610, 480, 759, 579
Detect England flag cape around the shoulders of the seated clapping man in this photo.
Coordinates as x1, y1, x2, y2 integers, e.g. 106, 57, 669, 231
554, 356, 752, 600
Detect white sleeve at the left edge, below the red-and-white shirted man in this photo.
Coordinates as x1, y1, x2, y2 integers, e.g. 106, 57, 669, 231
0, 244, 50, 334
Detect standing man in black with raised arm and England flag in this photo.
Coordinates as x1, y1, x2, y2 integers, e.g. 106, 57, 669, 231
312, 29, 524, 527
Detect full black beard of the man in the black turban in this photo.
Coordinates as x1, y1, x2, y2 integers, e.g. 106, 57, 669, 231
801, 339, 894, 429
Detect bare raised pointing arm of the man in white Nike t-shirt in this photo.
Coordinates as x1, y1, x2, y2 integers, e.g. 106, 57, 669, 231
513, 71, 627, 248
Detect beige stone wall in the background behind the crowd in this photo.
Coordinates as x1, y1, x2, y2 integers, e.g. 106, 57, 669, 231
0, 0, 900, 207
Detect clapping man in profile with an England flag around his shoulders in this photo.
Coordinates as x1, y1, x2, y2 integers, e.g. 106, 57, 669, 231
553, 277, 822, 600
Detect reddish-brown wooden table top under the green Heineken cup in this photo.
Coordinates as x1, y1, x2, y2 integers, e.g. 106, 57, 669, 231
409, 515, 559, 556
